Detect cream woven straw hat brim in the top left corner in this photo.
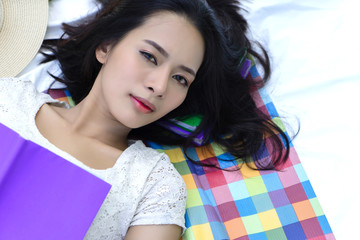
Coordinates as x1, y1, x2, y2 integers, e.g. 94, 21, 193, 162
0, 0, 49, 77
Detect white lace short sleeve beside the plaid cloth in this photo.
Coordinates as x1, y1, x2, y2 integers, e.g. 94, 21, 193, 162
127, 141, 186, 230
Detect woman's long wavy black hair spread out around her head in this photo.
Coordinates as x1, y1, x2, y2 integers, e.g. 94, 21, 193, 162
43, 0, 290, 169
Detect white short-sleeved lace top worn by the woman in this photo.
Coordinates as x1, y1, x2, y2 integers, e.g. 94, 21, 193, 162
0, 78, 186, 240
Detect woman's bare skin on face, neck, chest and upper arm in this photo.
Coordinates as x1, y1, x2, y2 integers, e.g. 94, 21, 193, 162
35, 13, 204, 240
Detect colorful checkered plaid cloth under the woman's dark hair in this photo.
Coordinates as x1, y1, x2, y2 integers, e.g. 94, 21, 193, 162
49, 63, 335, 240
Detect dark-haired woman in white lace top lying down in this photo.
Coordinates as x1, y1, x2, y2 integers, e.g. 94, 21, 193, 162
0, 0, 288, 239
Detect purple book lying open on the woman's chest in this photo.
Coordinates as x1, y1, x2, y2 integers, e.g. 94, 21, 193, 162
0, 124, 111, 240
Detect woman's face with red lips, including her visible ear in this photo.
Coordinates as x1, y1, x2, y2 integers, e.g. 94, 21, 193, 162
96, 13, 205, 128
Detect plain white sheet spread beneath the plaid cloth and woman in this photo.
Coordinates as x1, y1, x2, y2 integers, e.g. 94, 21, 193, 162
22, 0, 360, 240
